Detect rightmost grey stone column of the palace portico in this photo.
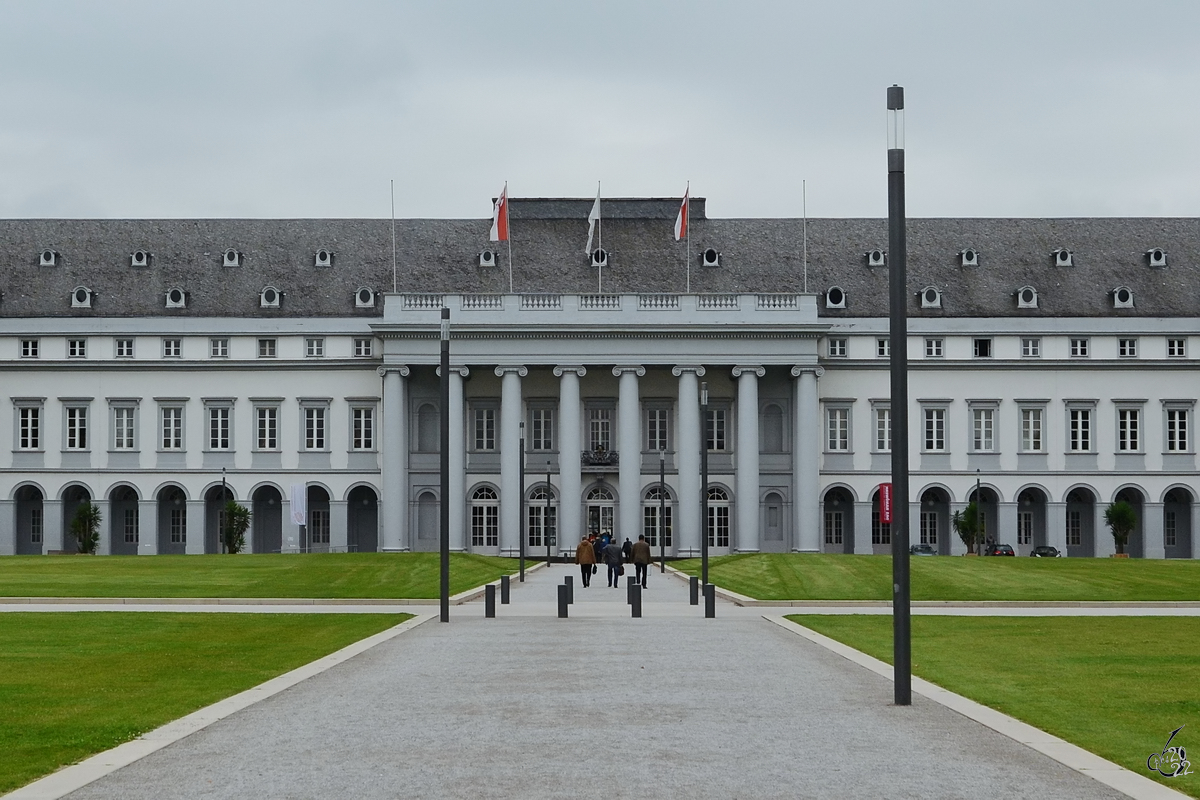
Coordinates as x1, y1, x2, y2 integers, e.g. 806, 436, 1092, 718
792, 365, 824, 553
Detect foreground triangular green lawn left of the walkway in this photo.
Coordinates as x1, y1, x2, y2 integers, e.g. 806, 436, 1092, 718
0, 612, 410, 794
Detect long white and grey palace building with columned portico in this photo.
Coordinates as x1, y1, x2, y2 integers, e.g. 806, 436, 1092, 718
0, 198, 1200, 558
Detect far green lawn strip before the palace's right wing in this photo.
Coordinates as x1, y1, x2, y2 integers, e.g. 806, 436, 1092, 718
676, 553, 1200, 601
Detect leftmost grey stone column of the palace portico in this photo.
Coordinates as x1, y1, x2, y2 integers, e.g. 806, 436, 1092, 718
379, 365, 412, 553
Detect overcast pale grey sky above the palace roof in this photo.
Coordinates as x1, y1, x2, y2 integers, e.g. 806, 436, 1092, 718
0, 0, 1200, 217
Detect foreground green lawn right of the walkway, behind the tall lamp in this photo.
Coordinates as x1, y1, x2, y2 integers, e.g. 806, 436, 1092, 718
788, 618, 1200, 796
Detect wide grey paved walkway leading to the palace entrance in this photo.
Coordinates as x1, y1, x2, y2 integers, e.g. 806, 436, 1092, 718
35, 566, 1161, 800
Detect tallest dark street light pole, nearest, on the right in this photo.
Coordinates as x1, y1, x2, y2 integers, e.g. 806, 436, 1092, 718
888, 86, 912, 705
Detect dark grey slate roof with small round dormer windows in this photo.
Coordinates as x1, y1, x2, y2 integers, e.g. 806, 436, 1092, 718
0, 198, 1200, 318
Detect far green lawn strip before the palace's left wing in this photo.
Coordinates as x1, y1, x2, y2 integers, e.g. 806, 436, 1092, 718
0, 553, 517, 599
